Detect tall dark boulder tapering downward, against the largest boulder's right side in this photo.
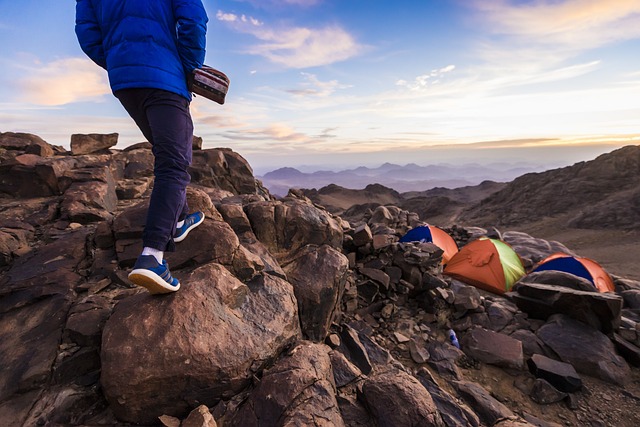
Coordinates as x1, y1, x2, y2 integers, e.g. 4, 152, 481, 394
283, 245, 349, 342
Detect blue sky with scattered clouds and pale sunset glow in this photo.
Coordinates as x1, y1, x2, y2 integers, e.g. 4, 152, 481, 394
0, 0, 640, 174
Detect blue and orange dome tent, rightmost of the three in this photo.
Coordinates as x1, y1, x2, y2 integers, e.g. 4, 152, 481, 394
532, 252, 616, 292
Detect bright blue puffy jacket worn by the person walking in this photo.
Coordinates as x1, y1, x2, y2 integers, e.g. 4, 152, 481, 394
76, 0, 208, 100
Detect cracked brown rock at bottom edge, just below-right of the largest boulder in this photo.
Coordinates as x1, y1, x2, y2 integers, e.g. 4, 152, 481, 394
225, 342, 344, 427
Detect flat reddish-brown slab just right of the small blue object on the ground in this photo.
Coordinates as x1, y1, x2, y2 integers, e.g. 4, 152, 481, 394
461, 328, 524, 369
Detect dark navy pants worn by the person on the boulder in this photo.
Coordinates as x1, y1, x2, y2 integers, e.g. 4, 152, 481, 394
115, 88, 193, 252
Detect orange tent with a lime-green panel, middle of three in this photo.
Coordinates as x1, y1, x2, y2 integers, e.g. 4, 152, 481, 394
443, 237, 525, 294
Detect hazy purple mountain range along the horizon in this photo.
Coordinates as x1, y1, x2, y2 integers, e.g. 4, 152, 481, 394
256, 163, 545, 196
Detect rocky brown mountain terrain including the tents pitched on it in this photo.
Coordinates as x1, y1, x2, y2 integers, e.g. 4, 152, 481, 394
0, 132, 640, 427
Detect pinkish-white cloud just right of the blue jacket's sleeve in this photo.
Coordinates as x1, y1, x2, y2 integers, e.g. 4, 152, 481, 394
216, 11, 363, 68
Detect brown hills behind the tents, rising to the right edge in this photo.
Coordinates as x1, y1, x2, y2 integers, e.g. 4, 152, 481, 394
300, 145, 640, 230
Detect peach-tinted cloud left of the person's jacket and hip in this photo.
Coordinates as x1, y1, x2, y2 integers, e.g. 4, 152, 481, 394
16, 58, 111, 106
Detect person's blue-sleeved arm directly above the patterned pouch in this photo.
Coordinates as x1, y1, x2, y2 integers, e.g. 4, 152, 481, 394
173, 0, 209, 77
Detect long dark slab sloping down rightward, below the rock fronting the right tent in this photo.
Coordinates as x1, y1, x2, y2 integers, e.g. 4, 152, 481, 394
537, 314, 630, 385
